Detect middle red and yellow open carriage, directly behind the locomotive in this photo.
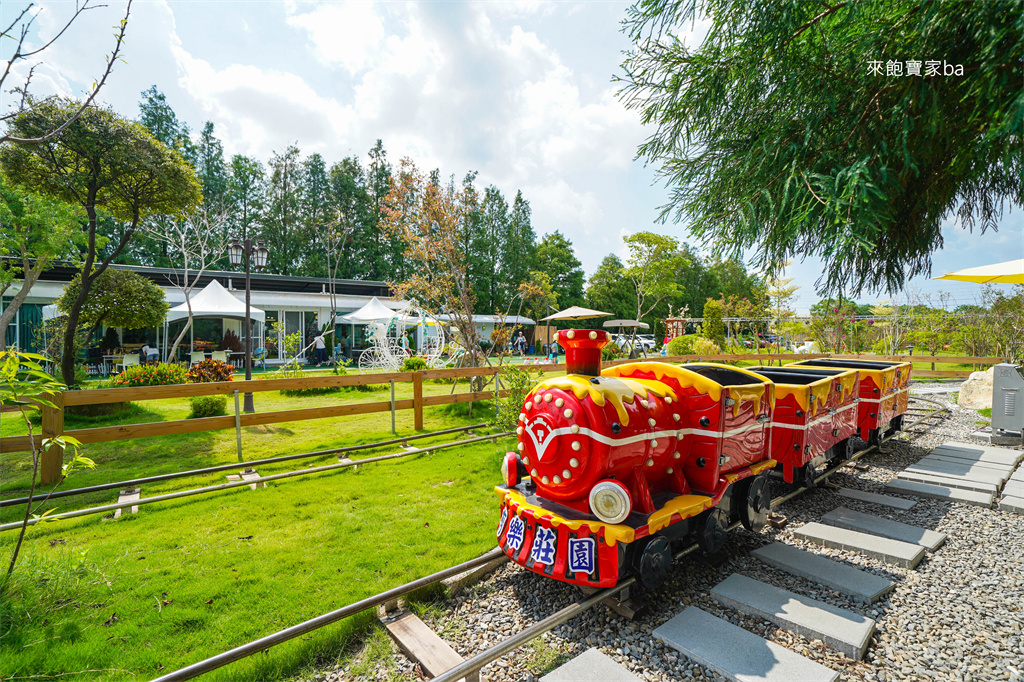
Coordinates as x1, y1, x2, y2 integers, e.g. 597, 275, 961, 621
741, 367, 859, 487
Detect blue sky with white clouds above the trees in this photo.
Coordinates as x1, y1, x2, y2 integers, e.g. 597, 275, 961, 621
9, 0, 1024, 312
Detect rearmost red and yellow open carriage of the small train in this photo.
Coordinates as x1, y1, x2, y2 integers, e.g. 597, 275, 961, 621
785, 357, 912, 444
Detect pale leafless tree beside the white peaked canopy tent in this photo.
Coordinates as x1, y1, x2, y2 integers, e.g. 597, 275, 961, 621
145, 207, 228, 359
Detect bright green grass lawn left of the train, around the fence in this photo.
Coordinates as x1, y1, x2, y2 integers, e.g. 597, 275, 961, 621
0, 411, 510, 680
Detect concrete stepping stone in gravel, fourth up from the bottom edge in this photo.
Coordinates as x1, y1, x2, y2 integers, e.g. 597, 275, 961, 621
751, 543, 896, 604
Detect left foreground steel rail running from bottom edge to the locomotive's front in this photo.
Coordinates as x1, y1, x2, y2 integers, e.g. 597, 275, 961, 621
153, 547, 505, 682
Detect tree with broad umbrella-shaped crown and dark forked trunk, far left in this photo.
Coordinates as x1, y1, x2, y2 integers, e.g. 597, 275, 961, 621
0, 98, 202, 384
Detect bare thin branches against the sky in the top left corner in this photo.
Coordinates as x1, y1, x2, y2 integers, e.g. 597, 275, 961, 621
0, 0, 132, 144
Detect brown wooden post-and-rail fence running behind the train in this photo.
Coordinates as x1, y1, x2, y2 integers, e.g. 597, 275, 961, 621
0, 353, 1002, 484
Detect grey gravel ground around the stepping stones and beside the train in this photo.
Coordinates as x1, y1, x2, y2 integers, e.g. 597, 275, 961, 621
309, 384, 1024, 682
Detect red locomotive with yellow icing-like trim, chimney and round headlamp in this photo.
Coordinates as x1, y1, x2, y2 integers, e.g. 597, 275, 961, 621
495, 330, 775, 588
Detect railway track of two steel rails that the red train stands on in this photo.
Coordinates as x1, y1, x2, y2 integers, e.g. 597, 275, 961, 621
146, 396, 948, 682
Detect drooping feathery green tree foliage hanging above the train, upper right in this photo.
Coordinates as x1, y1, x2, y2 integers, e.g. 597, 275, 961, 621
621, 0, 1024, 295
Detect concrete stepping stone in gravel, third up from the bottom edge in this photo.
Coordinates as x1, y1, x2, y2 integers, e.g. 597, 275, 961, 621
711, 573, 874, 660
